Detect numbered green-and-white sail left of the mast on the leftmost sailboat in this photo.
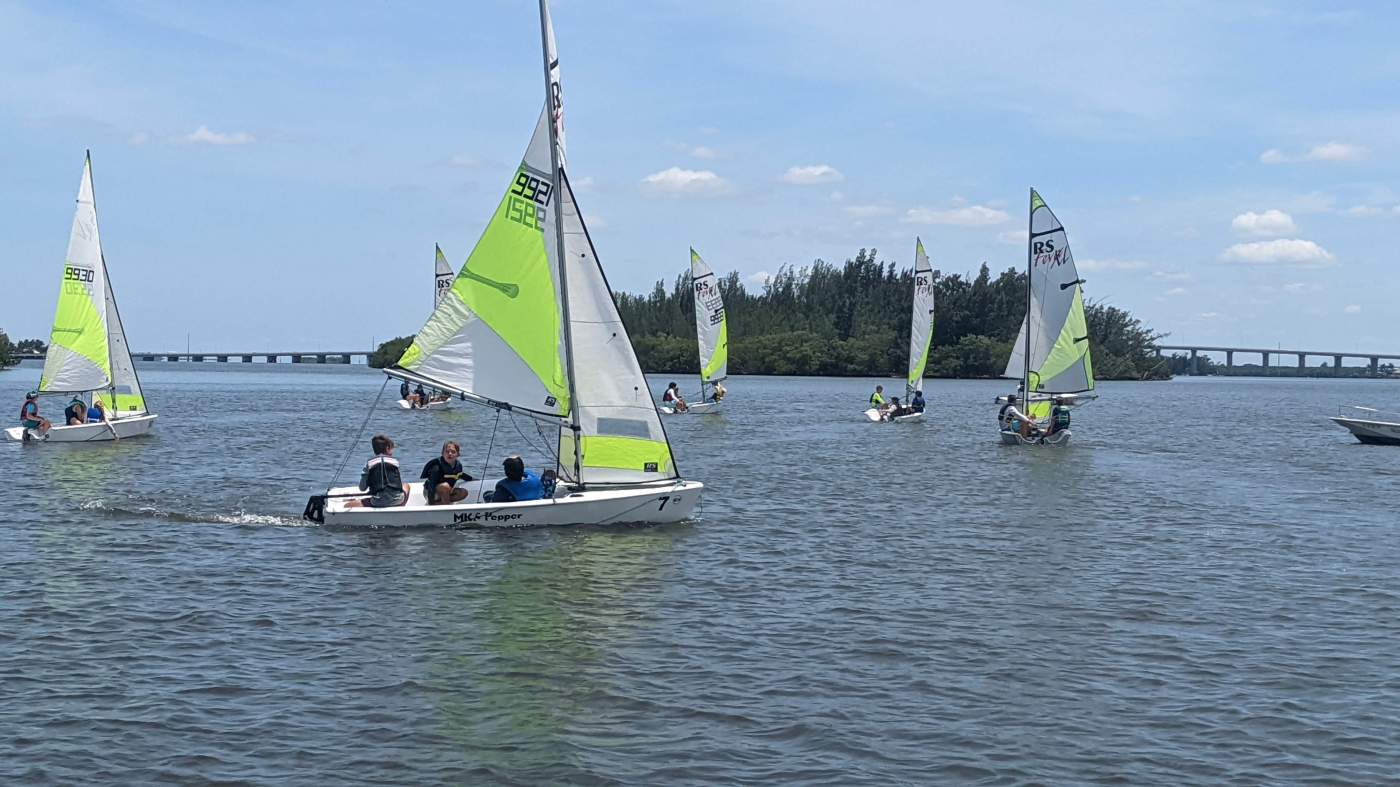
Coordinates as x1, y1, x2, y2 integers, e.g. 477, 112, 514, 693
39, 157, 112, 392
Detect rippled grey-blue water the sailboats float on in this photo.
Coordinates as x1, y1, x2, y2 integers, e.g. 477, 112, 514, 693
0, 364, 1400, 786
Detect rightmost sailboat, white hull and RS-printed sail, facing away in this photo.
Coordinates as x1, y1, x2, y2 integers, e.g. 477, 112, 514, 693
997, 189, 1093, 445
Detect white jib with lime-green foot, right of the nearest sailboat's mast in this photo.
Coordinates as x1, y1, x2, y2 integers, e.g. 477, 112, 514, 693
559, 172, 678, 483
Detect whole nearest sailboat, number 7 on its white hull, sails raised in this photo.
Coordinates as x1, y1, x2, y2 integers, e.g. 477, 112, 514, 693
304, 0, 704, 527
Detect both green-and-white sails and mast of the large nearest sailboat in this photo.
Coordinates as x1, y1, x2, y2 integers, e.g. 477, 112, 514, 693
393, 1, 679, 483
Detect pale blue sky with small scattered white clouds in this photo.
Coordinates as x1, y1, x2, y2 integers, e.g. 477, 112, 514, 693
0, 0, 1400, 351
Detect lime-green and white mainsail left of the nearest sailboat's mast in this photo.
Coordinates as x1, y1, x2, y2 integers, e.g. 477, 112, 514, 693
398, 112, 570, 417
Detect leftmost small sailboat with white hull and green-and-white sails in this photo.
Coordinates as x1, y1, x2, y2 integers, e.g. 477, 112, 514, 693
4, 151, 155, 443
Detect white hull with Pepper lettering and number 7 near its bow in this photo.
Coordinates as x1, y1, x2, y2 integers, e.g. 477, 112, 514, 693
315, 480, 704, 528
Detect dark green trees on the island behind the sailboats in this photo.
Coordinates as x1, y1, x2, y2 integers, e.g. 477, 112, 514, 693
370, 249, 1170, 379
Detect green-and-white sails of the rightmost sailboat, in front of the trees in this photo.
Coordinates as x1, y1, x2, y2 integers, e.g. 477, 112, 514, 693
1005, 189, 1093, 394
